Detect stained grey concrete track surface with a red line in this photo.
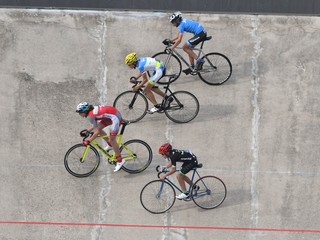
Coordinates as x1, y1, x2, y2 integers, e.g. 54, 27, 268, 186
0, 9, 320, 240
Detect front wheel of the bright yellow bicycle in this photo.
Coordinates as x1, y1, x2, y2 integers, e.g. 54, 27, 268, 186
64, 144, 100, 177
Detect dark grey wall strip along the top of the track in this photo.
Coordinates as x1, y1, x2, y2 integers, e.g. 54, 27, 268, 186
0, 0, 320, 15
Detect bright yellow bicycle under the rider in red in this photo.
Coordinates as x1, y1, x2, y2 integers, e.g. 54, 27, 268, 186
64, 121, 153, 178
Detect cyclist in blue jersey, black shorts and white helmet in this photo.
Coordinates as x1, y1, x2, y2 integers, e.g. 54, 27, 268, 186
169, 12, 207, 74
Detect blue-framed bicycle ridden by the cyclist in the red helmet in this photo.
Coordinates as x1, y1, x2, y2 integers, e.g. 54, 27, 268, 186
140, 163, 227, 214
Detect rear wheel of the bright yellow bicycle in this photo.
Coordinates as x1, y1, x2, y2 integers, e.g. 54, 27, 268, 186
120, 139, 153, 173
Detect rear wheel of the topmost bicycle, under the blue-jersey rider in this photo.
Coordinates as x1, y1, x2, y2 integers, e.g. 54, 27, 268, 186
198, 53, 232, 85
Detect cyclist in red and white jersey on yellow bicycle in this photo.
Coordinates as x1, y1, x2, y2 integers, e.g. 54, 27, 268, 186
76, 102, 125, 172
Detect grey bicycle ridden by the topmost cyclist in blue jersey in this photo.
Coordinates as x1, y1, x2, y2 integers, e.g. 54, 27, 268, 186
152, 36, 232, 85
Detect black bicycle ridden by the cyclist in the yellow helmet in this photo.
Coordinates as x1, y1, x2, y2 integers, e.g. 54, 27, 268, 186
113, 75, 200, 123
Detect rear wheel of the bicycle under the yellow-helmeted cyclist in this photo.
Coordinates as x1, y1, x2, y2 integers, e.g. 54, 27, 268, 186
164, 91, 200, 123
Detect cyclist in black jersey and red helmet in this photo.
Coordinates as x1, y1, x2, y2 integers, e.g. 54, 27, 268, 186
159, 143, 199, 200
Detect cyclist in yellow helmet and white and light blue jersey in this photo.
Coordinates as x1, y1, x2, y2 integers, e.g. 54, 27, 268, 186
125, 52, 168, 113
